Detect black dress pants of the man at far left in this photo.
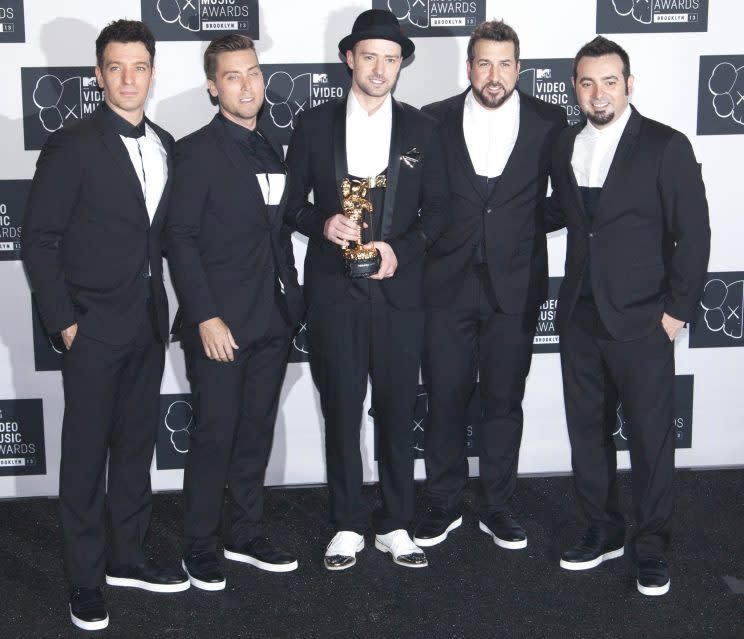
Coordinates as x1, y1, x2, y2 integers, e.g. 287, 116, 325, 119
59, 317, 165, 587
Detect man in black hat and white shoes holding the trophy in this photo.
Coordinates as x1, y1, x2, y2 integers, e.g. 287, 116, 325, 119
285, 9, 448, 570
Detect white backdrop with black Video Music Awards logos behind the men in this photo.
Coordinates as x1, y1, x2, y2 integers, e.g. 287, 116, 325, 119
0, 0, 744, 497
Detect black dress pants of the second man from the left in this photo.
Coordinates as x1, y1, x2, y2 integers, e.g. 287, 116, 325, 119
182, 318, 291, 555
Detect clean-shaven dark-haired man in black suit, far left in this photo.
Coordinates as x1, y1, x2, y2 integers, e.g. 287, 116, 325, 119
22, 20, 189, 630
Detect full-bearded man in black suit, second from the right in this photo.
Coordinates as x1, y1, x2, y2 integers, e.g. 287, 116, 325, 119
414, 21, 566, 549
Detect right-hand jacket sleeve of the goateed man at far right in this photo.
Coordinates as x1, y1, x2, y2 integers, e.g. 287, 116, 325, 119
658, 132, 710, 322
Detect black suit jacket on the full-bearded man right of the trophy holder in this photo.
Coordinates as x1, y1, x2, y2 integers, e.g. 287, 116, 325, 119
423, 89, 566, 313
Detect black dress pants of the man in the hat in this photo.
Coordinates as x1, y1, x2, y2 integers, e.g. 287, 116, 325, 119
308, 300, 424, 534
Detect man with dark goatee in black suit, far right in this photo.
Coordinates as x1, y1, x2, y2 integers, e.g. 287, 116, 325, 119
551, 36, 710, 595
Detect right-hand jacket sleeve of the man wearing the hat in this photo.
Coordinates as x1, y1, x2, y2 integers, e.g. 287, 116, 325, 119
388, 121, 450, 266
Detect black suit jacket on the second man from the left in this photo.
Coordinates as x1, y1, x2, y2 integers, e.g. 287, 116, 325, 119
166, 115, 304, 346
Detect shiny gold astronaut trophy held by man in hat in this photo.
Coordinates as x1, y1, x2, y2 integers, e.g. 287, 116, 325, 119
341, 175, 386, 277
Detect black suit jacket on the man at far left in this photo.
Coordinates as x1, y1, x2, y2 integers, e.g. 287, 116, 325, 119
22, 106, 173, 345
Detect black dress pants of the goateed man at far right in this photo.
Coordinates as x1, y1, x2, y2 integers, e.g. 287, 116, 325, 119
560, 301, 675, 559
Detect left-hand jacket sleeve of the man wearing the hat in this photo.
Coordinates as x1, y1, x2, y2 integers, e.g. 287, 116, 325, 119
284, 111, 332, 240
